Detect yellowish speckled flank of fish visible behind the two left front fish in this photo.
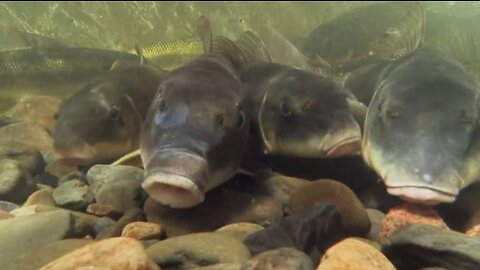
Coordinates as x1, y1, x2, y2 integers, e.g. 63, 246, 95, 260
128, 38, 203, 70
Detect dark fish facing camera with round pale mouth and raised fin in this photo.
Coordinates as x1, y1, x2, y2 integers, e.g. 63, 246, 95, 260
140, 16, 249, 208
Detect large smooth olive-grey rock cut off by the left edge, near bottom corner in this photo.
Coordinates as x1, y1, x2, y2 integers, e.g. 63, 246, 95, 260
0, 210, 73, 265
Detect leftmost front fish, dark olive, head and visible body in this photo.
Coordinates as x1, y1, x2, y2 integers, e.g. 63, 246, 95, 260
53, 64, 167, 166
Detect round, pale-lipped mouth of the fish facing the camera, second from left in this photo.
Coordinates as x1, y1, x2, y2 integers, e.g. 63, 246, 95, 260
142, 171, 205, 208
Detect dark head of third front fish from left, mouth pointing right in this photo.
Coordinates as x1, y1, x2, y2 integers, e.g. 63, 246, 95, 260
257, 70, 366, 158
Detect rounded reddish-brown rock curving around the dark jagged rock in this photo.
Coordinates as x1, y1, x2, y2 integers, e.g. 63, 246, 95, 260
289, 179, 371, 236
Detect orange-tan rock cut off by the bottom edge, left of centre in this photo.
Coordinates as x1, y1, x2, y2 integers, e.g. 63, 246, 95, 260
40, 237, 149, 270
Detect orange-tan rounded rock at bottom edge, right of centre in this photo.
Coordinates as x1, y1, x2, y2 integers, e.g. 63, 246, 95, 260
317, 238, 395, 270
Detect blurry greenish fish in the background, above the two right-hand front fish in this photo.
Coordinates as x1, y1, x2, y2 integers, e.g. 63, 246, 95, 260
301, 2, 425, 73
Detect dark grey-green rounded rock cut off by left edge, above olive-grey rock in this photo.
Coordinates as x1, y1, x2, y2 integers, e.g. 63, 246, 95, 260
0, 159, 36, 204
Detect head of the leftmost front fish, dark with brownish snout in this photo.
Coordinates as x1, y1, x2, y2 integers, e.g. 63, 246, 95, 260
53, 82, 142, 166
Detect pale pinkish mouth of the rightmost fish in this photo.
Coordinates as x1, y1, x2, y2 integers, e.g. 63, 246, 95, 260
387, 186, 458, 205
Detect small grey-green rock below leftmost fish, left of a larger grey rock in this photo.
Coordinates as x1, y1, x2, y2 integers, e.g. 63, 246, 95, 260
52, 180, 94, 211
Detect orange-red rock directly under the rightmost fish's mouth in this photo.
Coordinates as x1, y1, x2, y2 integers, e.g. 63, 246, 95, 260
380, 203, 448, 239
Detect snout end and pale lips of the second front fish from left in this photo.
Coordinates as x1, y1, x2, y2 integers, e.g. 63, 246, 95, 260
142, 150, 208, 208
